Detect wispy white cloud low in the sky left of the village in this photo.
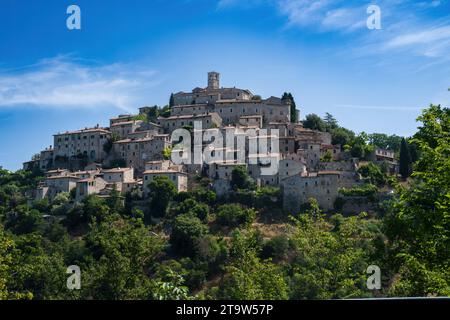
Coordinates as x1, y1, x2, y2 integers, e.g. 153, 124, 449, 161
0, 56, 160, 111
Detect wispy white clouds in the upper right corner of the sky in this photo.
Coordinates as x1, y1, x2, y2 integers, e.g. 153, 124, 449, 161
214, 0, 450, 59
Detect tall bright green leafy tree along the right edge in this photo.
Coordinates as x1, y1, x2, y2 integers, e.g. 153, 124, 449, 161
384, 105, 450, 296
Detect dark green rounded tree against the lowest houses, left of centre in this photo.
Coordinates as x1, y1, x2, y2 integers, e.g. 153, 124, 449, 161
148, 176, 177, 217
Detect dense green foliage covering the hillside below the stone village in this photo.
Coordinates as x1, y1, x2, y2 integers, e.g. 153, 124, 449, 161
0, 106, 450, 299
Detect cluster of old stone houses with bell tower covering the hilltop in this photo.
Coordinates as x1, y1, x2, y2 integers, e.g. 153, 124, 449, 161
24, 72, 395, 210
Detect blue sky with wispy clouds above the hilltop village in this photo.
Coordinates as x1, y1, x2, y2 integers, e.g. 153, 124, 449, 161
0, 0, 450, 170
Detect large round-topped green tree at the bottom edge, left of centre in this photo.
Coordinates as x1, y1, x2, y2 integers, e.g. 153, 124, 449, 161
82, 217, 164, 300
